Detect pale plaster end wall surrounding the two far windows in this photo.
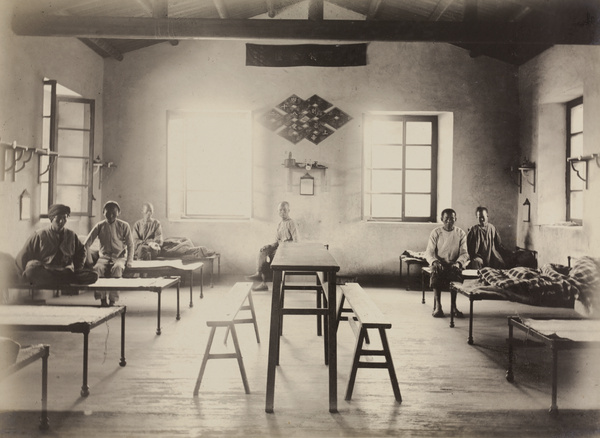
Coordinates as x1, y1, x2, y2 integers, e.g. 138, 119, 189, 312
103, 41, 518, 274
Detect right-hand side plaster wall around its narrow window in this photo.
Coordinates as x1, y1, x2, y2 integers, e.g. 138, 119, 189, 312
517, 46, 600, 264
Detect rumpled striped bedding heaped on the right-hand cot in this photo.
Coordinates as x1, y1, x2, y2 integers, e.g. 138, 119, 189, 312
479, 257, 600, 317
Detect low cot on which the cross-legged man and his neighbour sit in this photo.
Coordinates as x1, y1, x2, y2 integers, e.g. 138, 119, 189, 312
72, 277, 181, 335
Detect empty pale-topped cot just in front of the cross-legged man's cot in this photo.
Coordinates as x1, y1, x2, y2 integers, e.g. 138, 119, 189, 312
0, 305, 127, 397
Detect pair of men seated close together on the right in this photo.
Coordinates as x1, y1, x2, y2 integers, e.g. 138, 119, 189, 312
425, 207, 507, 318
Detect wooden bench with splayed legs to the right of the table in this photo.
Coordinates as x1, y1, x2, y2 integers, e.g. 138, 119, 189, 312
338, 283, 402, 403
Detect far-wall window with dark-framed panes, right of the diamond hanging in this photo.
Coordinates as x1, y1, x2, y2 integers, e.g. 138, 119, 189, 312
363, 114, 438, 222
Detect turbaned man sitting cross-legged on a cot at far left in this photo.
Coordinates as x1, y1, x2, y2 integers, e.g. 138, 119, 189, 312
16, 204, 98, 286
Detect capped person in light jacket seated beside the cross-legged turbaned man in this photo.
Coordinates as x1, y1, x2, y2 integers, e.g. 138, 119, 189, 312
84, 201, 133, 307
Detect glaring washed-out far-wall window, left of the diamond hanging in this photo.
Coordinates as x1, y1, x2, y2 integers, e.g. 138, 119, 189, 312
167, 111, 252, 219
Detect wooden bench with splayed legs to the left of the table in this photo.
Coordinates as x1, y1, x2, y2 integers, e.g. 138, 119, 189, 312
194, 282, 260, 396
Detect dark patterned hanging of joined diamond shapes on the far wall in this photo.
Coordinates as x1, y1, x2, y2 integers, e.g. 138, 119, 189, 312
261, 94, 352, 144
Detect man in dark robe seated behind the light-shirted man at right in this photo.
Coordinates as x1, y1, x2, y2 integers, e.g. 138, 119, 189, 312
467, 207, 507, 269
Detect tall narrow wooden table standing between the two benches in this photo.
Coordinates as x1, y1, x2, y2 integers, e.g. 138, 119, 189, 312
265, 242, 340, 413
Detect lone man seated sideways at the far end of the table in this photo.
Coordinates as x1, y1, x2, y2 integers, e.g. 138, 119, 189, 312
248, 201, 298, 290
